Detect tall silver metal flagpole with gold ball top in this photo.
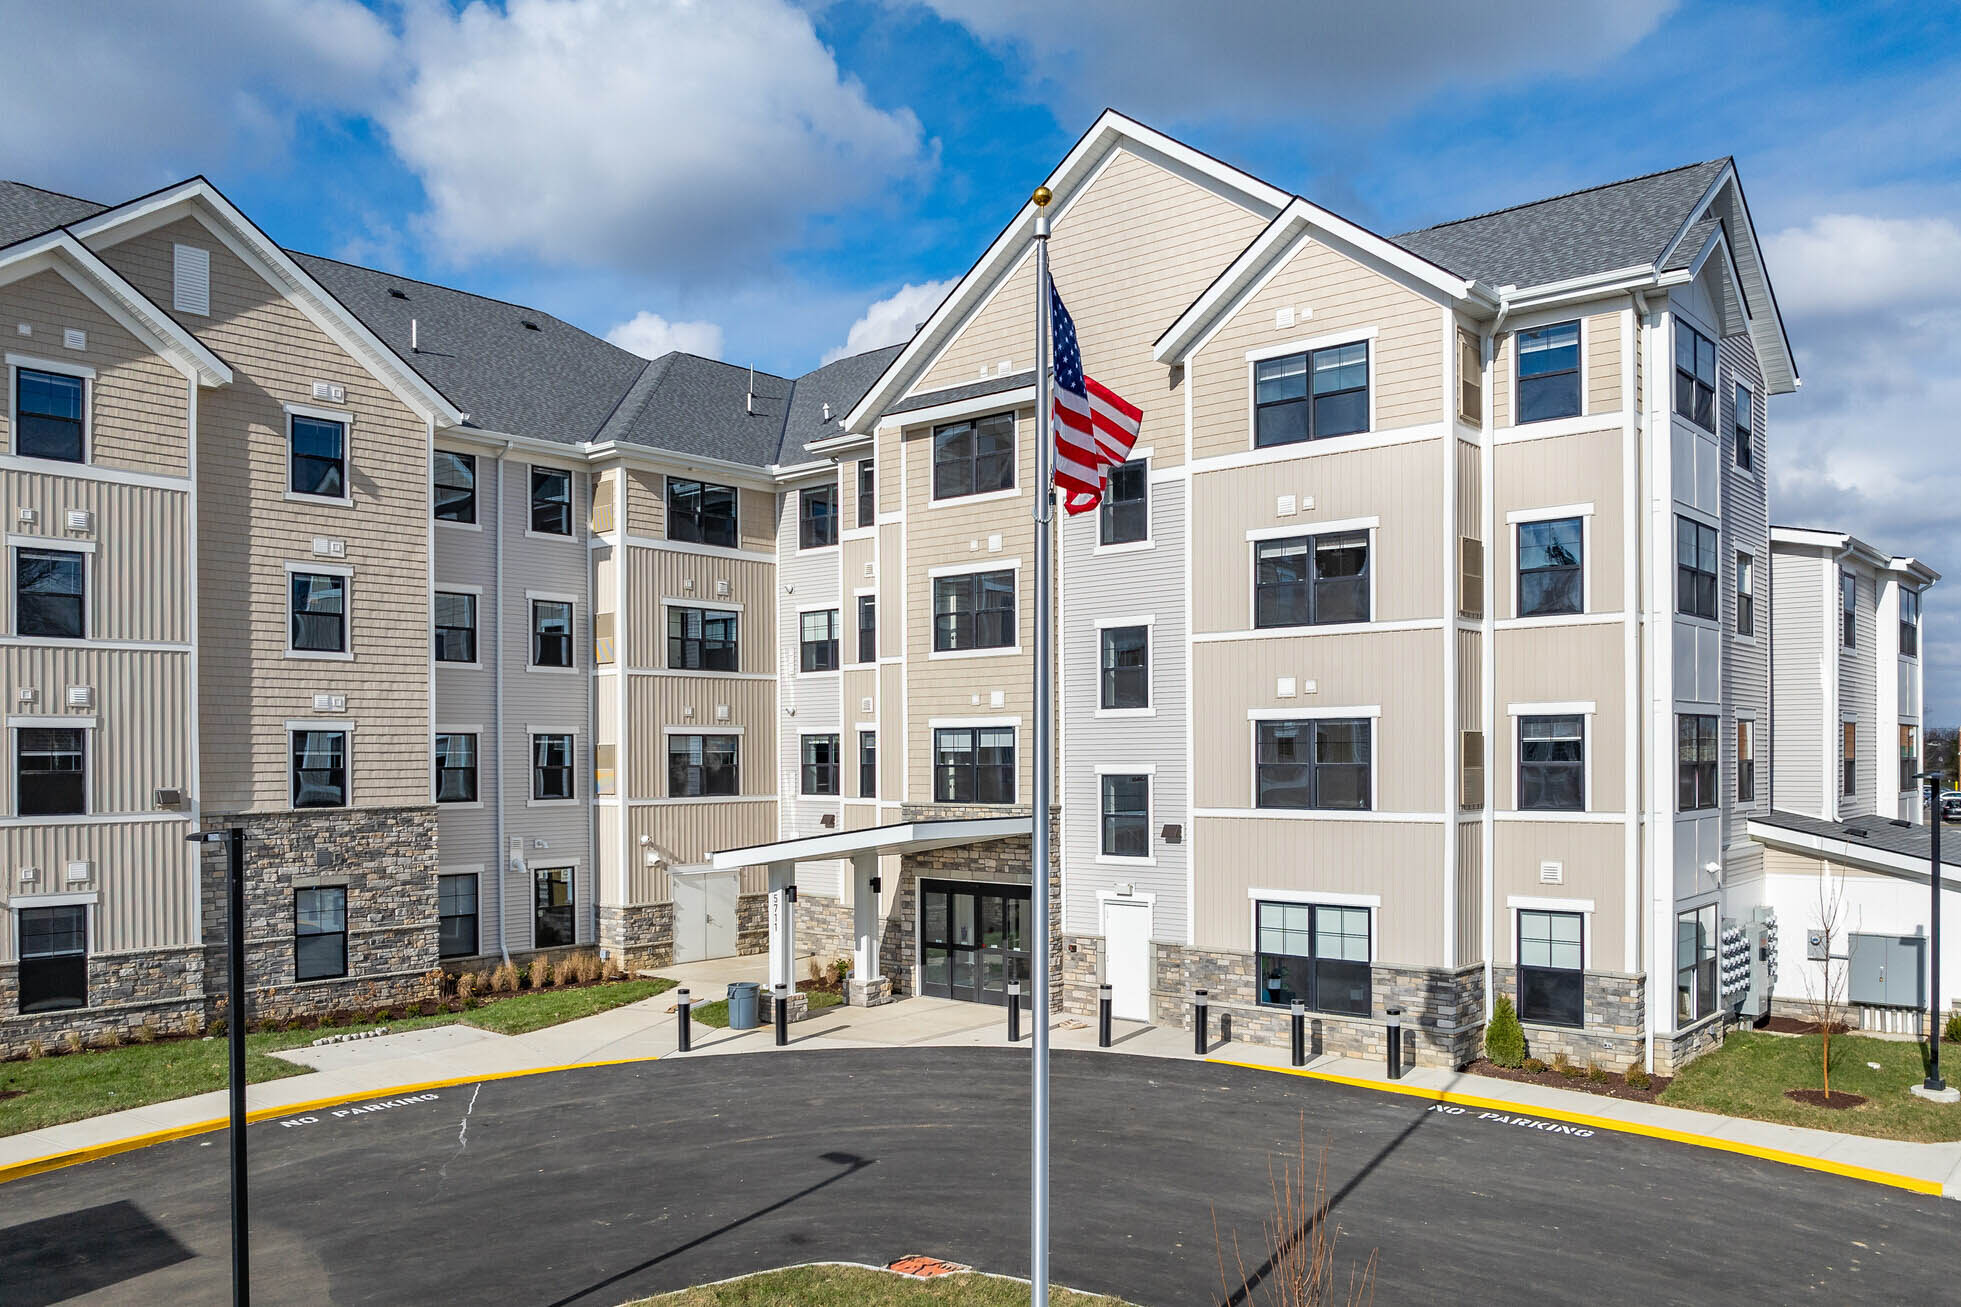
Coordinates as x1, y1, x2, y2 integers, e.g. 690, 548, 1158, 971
1010, 186, 1055, 1307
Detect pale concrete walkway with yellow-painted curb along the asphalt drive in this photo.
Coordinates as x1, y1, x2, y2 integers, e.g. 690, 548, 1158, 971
0, 977, 1961, 1197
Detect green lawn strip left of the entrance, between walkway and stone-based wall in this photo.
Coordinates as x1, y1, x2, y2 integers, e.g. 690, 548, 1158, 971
0, 979, 675, 1136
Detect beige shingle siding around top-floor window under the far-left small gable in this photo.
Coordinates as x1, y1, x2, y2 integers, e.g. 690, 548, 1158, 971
0, 271, 190, 472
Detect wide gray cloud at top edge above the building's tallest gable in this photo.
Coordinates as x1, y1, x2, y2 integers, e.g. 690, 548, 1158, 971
888, 0, 1675, 120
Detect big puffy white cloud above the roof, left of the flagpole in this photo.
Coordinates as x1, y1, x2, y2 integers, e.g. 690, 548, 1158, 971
380, 0, 924, 283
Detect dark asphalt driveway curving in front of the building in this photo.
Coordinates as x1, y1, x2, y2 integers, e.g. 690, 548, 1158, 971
0, 1048, 1957, 1307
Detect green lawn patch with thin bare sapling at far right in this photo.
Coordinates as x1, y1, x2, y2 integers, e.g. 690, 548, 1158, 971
1661, 1030, 1961, 1142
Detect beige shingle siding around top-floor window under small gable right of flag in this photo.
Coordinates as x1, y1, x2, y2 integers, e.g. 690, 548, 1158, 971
1186, 239, 1445, 463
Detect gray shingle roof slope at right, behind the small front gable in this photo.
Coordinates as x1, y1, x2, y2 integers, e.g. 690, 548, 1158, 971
1394, 159, 1730, 287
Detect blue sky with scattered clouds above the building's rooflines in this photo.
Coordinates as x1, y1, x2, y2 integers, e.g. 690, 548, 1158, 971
11, 0, 1961, 722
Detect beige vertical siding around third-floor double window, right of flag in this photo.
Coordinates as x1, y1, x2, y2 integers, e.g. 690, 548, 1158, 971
1190, 442, 1455, 632
